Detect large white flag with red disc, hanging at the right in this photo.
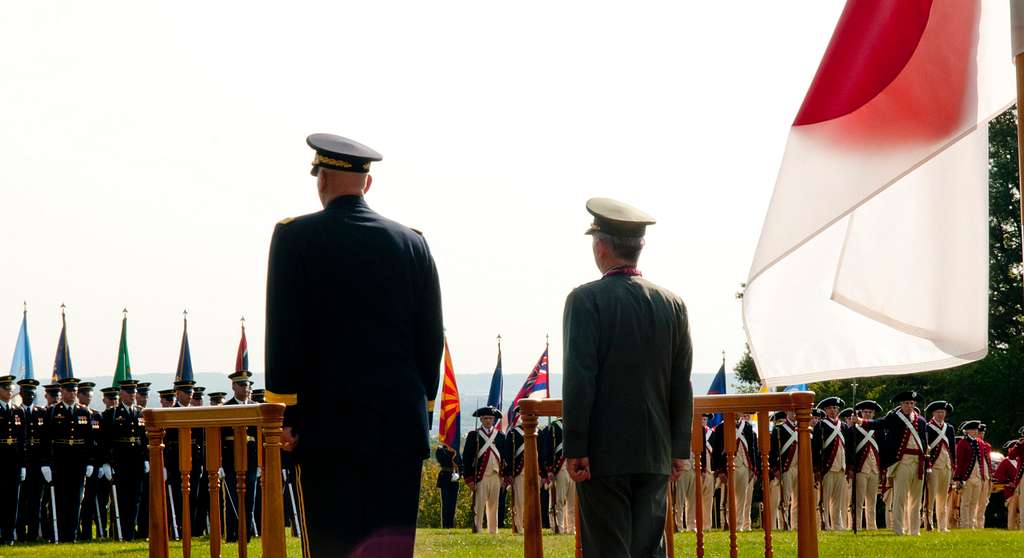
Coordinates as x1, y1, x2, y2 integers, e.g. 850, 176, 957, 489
742, 0, 1015, 386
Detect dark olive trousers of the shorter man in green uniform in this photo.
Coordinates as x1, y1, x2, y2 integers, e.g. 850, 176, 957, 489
577, 475, 669, 558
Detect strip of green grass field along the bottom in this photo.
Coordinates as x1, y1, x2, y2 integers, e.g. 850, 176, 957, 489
0, 529, 1024, 558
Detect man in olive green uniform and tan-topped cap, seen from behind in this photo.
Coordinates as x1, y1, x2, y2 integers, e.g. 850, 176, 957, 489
562, 199, 693, 558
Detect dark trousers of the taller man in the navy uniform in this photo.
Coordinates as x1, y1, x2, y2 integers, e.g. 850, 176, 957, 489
296, 455, 423, 558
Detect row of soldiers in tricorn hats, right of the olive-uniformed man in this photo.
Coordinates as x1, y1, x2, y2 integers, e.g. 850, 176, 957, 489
674, 391, 1024, 535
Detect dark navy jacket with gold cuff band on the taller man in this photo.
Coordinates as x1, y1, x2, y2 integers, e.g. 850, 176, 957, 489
266, 196, 443, 463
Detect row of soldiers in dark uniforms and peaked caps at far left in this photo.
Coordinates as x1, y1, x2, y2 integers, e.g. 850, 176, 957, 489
0, 372, 298, 545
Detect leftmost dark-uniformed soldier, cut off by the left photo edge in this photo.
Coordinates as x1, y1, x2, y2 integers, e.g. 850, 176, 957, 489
0, 376, 29, 545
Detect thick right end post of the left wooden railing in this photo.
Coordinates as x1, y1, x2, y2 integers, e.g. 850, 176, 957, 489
257, 405, 288, 556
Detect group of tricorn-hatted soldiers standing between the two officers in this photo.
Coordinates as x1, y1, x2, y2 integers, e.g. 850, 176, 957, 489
435, 406, 575, 533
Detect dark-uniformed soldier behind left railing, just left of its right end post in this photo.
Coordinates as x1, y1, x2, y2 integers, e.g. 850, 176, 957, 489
220, 371, 257, 542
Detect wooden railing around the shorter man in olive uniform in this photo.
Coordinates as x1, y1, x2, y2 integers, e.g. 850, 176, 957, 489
520, 391, 818, 558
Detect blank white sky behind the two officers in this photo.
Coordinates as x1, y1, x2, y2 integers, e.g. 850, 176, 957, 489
0, 0, 843, 377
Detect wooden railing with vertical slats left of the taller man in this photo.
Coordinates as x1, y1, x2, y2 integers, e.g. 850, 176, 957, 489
142, 403, 285, 558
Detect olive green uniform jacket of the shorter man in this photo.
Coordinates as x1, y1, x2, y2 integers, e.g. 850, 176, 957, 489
562, 274, 693, 477
